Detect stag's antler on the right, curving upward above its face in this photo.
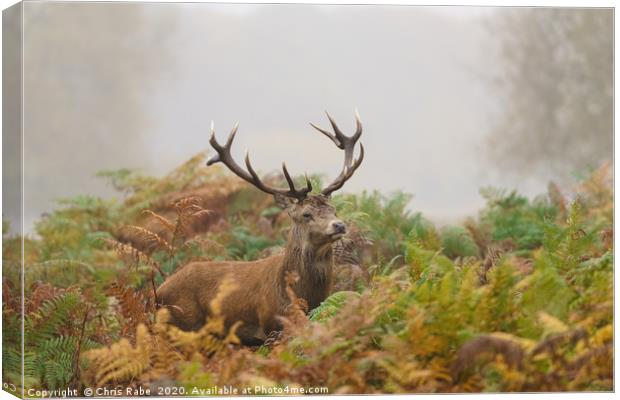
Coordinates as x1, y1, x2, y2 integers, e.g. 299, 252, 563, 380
310, 111, 364, 196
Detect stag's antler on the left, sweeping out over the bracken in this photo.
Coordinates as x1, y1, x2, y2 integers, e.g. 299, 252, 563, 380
207, 123, 312, 201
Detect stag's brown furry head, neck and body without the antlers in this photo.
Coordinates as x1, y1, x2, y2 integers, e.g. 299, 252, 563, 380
157, 195, 344, 344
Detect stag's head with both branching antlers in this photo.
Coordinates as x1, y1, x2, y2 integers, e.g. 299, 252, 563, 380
207, 113, 364, 248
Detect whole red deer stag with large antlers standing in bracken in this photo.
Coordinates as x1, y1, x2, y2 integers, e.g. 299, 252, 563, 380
157, 114, 364, 345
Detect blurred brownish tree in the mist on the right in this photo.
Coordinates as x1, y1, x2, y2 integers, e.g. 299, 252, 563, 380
487, 8, 613, 177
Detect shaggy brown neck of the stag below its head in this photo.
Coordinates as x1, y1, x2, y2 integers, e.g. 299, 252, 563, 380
280, 229, 333, 309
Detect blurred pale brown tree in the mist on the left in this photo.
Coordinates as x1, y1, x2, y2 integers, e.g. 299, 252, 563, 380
20, 2, 176, 230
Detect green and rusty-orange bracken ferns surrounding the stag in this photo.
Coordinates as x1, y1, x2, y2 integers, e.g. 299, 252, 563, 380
2, 154, 613, 395
